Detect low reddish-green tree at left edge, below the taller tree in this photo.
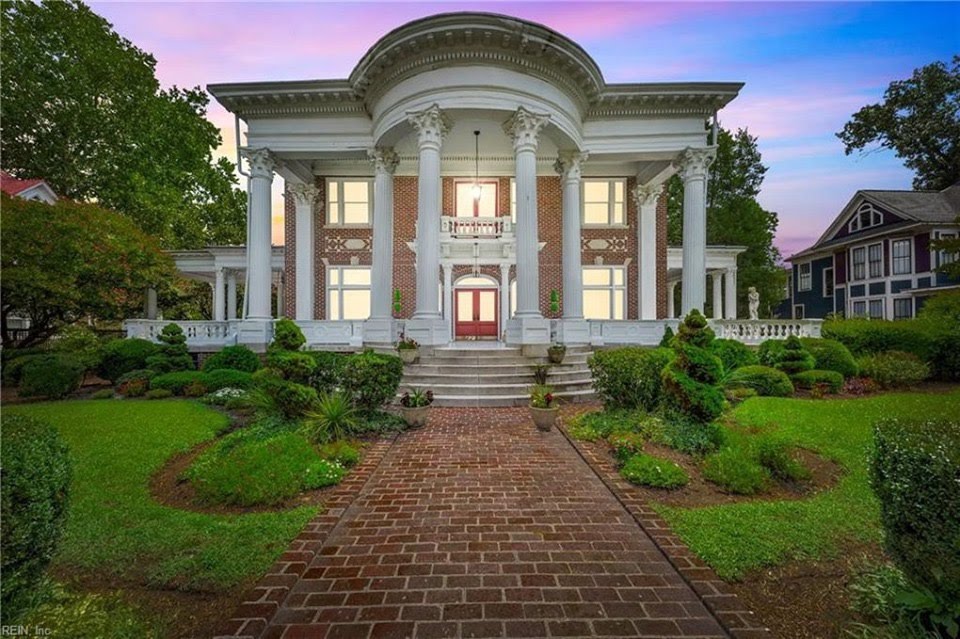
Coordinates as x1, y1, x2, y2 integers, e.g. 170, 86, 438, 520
0, 196, 173, 348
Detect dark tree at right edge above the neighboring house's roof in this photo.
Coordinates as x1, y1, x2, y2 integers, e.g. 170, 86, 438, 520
837, 56, 960, 191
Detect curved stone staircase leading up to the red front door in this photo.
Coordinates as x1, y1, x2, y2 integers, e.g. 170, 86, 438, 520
399, 346, 594, 406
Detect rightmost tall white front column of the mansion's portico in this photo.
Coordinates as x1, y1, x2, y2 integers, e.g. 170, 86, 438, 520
677, 147, 716, 315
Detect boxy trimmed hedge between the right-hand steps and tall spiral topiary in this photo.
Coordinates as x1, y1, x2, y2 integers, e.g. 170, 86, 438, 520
588, 346, 674, 411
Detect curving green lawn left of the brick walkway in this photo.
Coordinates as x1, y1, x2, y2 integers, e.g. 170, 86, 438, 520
7, 400, 317, 592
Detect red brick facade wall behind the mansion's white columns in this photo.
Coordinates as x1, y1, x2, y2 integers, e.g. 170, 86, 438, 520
284, 175, 667, 319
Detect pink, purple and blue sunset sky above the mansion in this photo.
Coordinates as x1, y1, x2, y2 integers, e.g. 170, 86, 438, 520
86, 1, 960, 256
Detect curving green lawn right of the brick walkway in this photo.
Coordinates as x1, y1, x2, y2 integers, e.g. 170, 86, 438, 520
654, 390, 960, 579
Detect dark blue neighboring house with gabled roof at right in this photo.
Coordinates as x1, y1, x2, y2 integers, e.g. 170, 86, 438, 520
788, 183, 960, 319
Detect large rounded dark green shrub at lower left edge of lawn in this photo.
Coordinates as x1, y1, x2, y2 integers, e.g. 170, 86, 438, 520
0, 411, 71, 620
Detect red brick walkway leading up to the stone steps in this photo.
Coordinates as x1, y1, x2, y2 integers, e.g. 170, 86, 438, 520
221, 409, 740, 639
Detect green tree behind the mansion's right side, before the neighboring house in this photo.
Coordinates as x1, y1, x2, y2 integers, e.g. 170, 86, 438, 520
667, 128, 786, 317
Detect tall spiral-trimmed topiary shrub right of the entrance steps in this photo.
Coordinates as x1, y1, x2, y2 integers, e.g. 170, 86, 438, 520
661, 309, 724, 423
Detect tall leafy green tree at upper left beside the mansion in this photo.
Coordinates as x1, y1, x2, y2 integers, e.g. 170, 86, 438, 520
0, 0, 246, 248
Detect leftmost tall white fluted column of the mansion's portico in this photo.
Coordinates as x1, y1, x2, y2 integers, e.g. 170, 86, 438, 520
244, 149, 277, 320
